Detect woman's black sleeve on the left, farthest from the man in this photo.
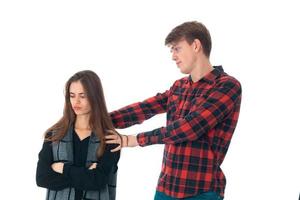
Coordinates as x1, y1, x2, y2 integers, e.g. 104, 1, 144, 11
36, 142, 71, 190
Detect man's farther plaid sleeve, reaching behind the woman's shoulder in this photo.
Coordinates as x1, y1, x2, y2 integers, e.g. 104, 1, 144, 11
110, 90, 169, 128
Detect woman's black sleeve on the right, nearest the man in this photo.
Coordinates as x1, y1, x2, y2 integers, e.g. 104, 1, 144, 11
63, 144, 120, 190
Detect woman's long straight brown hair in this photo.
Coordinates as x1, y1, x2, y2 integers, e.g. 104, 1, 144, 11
45, 70, 118, 158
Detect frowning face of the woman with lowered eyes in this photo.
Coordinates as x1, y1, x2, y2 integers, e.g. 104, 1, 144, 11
70, 81, 91, 115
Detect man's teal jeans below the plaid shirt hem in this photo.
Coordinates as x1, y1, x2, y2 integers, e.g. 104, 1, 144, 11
154, 191, 223, 200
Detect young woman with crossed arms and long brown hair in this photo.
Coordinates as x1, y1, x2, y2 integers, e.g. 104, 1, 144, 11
36, 70, 120, 200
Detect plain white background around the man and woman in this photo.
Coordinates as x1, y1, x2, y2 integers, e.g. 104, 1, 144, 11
0, 0, 300, 200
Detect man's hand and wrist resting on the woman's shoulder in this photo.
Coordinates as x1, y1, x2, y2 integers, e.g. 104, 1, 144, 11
105, 130, 138, 152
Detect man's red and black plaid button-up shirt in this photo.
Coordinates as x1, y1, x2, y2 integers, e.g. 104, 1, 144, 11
110, 66, 241, 198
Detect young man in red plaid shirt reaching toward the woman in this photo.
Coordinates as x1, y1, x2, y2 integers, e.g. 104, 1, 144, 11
107, 21, 241, 200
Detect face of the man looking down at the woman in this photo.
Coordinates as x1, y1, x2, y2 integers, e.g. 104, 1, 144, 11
169, 39, 196, 74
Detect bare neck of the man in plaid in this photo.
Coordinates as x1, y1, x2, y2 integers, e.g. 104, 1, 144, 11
190, 58, 214, 82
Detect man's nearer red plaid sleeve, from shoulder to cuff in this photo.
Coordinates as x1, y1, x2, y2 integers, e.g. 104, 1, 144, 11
137, 77, 242, 146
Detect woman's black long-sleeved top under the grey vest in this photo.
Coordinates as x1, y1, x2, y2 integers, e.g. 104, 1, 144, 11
36, 131, 120, 200
